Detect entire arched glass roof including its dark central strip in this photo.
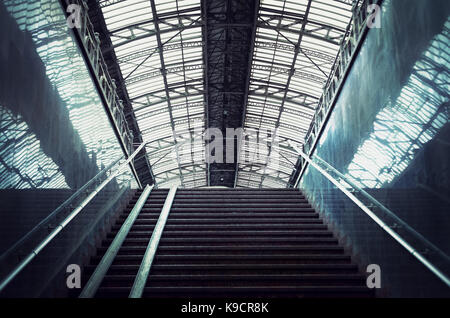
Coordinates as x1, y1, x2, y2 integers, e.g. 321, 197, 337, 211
88, 0, 352, 187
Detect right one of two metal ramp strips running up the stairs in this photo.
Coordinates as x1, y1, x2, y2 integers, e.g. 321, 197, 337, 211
128, 185, 177, 298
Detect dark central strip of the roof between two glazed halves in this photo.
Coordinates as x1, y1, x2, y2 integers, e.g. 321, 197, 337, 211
203, 0, 257, 187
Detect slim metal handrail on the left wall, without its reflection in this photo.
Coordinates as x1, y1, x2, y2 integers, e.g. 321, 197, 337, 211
0, 142, 146, 292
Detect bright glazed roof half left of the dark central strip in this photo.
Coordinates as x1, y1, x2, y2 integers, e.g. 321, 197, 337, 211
100, 0, 207, 188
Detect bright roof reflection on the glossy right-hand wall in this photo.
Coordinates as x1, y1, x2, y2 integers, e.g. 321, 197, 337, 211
347, 20, 450, 188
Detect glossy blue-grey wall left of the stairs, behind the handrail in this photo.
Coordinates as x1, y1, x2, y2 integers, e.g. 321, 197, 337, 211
0, 0, 137, 297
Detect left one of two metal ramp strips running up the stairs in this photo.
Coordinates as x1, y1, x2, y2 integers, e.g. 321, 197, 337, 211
79, 185, 153, 298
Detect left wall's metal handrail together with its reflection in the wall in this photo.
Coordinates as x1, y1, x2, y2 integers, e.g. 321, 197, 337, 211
0, 142, 146, 293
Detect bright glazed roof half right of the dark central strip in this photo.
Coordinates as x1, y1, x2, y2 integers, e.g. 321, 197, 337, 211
236, 0, 351, 188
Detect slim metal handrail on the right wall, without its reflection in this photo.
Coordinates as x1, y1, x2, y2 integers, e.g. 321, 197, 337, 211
289, 141, 450, 287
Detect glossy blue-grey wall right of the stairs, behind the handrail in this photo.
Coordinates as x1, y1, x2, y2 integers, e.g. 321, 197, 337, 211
298, 0, 450, 296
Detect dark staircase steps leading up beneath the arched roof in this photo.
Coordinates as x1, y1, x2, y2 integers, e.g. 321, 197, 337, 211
84, 189, 373, 298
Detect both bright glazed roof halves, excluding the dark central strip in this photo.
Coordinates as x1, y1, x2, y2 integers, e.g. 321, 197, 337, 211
99, 0, 352, 187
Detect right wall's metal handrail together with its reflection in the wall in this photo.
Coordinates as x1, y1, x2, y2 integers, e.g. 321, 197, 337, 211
289, 141, 450, 287
